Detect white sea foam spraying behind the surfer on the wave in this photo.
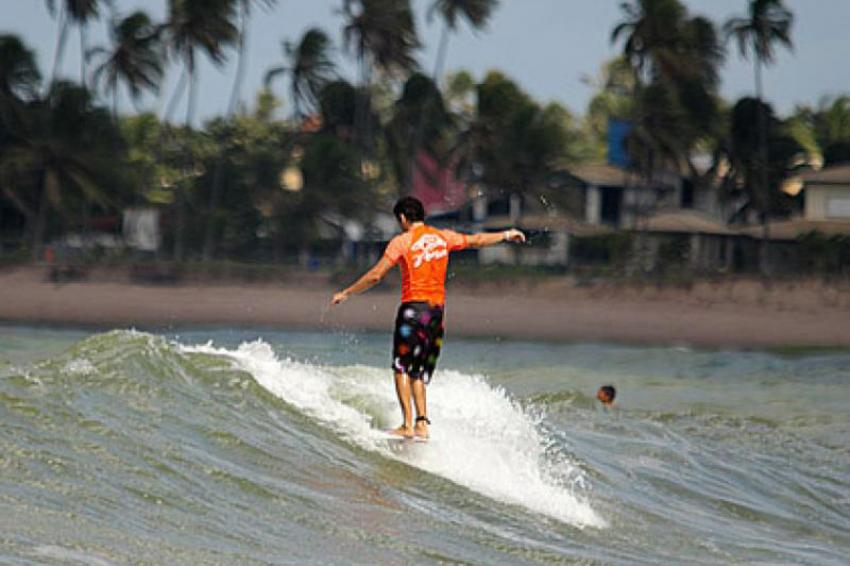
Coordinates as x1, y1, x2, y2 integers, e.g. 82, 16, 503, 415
181, 340, 606, 527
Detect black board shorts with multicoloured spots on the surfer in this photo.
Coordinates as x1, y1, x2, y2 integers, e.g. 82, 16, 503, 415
392, 302, 443, 383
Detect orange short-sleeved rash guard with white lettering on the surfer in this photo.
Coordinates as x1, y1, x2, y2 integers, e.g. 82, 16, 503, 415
384, 224, 468, 305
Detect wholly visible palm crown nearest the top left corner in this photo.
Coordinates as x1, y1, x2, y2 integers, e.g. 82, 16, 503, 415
87, 11, 164, 118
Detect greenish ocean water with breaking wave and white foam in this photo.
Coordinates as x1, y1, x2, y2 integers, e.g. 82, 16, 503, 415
0, 327, 850, 566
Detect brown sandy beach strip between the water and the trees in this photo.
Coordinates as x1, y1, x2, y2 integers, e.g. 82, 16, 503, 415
0, 267, 850, 348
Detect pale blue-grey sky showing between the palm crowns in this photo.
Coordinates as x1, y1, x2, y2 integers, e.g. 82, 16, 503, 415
0, 0, 850, 120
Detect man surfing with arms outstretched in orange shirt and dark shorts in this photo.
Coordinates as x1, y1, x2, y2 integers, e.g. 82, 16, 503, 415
332, 197, 525, 438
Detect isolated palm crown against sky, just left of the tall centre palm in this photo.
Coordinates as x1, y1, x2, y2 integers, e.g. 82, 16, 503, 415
265, 28, 336, 118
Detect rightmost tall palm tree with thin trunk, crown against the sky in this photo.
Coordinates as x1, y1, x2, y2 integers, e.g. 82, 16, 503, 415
724, 0, 794, 275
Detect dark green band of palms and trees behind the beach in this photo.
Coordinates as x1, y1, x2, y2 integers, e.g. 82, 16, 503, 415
0, 0, 850, 268
